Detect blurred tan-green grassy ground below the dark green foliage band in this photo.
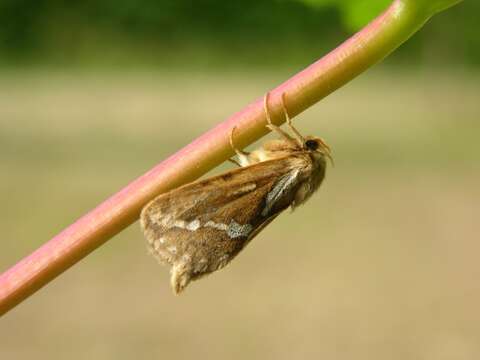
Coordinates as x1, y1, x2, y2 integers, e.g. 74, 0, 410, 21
0, 71, 480, 360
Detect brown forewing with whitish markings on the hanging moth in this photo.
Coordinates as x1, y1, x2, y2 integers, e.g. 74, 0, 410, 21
141, 156, 318, 293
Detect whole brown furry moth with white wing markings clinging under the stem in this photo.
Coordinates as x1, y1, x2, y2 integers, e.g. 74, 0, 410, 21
140, 93, 331, 294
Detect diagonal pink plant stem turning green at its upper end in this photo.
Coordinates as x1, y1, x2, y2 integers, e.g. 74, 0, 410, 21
0, 0, 458, 314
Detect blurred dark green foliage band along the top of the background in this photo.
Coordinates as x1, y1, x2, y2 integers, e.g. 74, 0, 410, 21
0, 0, 480, 65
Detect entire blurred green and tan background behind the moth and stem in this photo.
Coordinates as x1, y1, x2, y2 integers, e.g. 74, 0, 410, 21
0, 0, 480, 360
